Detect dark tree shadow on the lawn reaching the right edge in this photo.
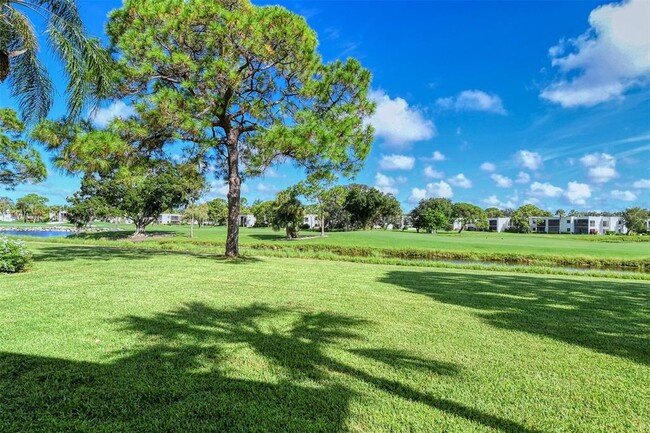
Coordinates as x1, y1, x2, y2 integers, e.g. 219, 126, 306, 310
381, 271, 650, 365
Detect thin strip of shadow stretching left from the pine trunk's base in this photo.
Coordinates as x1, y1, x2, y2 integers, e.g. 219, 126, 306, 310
34, 244, 260, 265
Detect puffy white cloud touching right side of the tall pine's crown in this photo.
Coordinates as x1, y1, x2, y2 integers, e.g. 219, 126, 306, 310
366, 90, 437, 148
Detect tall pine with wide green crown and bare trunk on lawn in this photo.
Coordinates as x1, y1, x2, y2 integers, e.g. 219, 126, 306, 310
107, 0, 374, 256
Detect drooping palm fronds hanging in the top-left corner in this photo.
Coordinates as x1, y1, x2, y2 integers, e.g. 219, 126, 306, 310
0, 0, 111, 121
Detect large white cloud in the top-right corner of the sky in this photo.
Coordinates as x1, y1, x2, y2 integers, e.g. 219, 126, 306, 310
540, 0, 650, 107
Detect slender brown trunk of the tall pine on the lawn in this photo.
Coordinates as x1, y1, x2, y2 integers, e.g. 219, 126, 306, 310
226, 130, 241, 257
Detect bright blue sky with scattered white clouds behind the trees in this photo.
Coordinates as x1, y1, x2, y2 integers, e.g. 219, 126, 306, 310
0, 0, 650, 210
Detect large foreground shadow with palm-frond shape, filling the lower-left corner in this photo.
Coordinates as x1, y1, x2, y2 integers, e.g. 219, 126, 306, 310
0, 303, 536, 433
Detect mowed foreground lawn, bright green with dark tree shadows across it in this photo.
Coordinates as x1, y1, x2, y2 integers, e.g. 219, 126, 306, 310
0, 244, 650, 432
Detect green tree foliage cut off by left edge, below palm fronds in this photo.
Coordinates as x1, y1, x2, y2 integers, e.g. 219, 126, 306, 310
0, 108, 47, 187
